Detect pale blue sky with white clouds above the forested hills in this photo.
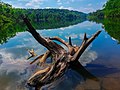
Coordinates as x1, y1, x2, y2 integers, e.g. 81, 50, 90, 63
1, 0, 107, 13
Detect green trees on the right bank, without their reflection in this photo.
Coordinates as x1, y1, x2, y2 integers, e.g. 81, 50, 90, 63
88, 0, 120, 20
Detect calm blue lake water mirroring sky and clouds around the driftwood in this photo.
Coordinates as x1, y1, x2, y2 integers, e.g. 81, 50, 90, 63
0, 21, 120, 90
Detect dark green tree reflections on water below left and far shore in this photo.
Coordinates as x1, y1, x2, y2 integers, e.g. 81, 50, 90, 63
0, 19, 84, 44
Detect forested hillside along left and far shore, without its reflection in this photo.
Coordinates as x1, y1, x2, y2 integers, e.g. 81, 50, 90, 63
0, 2, 86, 23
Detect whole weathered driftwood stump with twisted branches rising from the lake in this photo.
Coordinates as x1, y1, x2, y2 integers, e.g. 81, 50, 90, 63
23, 17, 101, 90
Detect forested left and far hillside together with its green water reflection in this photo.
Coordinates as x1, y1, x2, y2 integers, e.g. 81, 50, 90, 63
0, 1, 86, 43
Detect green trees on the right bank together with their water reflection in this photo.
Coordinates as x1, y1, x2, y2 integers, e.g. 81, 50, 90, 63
87, 0, 120, 44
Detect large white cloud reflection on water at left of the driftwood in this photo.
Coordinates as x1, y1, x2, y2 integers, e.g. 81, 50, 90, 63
0, 50, 29, 74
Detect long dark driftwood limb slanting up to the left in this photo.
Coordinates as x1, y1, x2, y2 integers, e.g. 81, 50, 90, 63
23, 17, 65, 54
